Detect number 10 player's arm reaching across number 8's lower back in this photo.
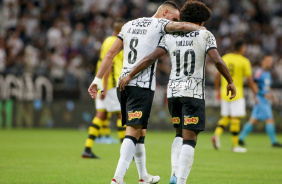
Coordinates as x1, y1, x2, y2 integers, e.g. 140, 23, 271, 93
118, 47, 166, 91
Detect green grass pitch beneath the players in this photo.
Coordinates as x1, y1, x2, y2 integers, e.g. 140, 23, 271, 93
0, 129, 282, 184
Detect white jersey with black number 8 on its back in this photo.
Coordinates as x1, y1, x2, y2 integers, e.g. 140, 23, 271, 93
118, 17, 170, 90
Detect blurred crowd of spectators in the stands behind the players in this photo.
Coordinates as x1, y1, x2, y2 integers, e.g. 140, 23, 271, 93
0, 0, 282, 95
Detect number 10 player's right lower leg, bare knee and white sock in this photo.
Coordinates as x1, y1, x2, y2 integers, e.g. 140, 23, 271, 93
177, 129, 198, 184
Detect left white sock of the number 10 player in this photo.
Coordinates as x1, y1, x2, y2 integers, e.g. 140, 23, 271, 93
171, 137, 183, 175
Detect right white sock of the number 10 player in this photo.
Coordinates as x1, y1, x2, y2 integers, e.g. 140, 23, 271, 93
177, 144, 195, 184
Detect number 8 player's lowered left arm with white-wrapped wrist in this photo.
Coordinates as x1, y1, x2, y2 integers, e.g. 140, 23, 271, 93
88, 38, 123, 99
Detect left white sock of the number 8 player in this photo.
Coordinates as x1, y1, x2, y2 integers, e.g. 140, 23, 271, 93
114, 138, 135, 182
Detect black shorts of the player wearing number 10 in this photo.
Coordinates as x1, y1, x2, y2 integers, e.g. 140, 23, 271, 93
167, 97, 205, 131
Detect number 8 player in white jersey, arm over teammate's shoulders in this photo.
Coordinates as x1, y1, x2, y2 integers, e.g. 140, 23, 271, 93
88, 1, 204, 184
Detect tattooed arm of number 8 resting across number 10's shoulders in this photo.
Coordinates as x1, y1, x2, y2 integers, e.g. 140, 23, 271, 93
165, 22, 206, 33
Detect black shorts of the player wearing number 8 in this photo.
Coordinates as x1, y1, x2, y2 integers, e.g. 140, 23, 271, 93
117, 86, 154, 129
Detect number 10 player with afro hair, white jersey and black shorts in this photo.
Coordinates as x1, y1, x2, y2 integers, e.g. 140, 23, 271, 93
118, 1, 236, 184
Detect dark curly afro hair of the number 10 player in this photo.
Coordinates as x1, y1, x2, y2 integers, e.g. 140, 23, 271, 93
180, 0, 212, 23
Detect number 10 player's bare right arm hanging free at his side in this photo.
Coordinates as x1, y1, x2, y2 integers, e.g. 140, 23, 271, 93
208, 49, 236, 99
